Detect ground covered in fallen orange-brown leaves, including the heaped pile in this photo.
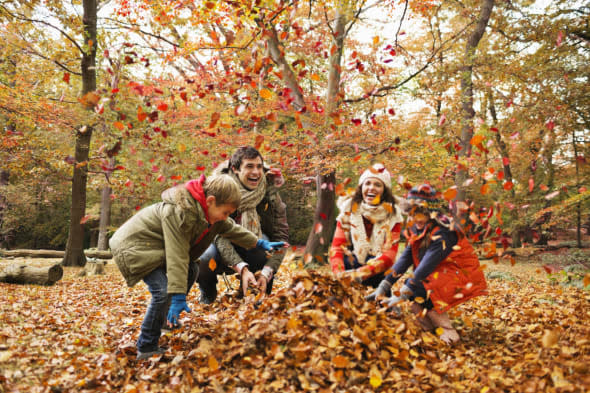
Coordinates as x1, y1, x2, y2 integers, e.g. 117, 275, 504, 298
0, 251, 590, 392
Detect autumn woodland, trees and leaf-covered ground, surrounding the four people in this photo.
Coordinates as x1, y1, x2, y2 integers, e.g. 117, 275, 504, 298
0, 0, 590, 393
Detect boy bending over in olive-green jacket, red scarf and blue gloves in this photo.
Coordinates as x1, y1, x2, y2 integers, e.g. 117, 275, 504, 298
109, 175, 284, 359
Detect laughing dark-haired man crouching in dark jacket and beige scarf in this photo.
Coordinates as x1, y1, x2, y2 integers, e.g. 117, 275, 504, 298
198, 146, 289, 304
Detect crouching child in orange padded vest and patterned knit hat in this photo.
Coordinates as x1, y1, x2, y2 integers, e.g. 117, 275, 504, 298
367, 184, 486, 344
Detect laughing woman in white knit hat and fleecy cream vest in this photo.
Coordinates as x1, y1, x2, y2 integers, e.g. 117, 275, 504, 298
330, 164, 403, 288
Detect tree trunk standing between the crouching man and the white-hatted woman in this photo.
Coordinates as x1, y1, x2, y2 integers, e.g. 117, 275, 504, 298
304, 12, 346, 263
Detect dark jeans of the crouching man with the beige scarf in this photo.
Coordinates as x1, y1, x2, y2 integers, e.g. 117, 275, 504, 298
197, 244, 274, 300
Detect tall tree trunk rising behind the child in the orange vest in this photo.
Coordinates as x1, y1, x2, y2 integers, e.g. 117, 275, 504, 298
455, 0, 494, 208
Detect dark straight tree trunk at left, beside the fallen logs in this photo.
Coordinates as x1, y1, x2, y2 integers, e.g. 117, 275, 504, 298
62, 0, 97, 266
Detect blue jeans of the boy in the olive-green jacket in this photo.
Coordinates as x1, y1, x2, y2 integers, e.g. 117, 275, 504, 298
137, 262, 199, 352
